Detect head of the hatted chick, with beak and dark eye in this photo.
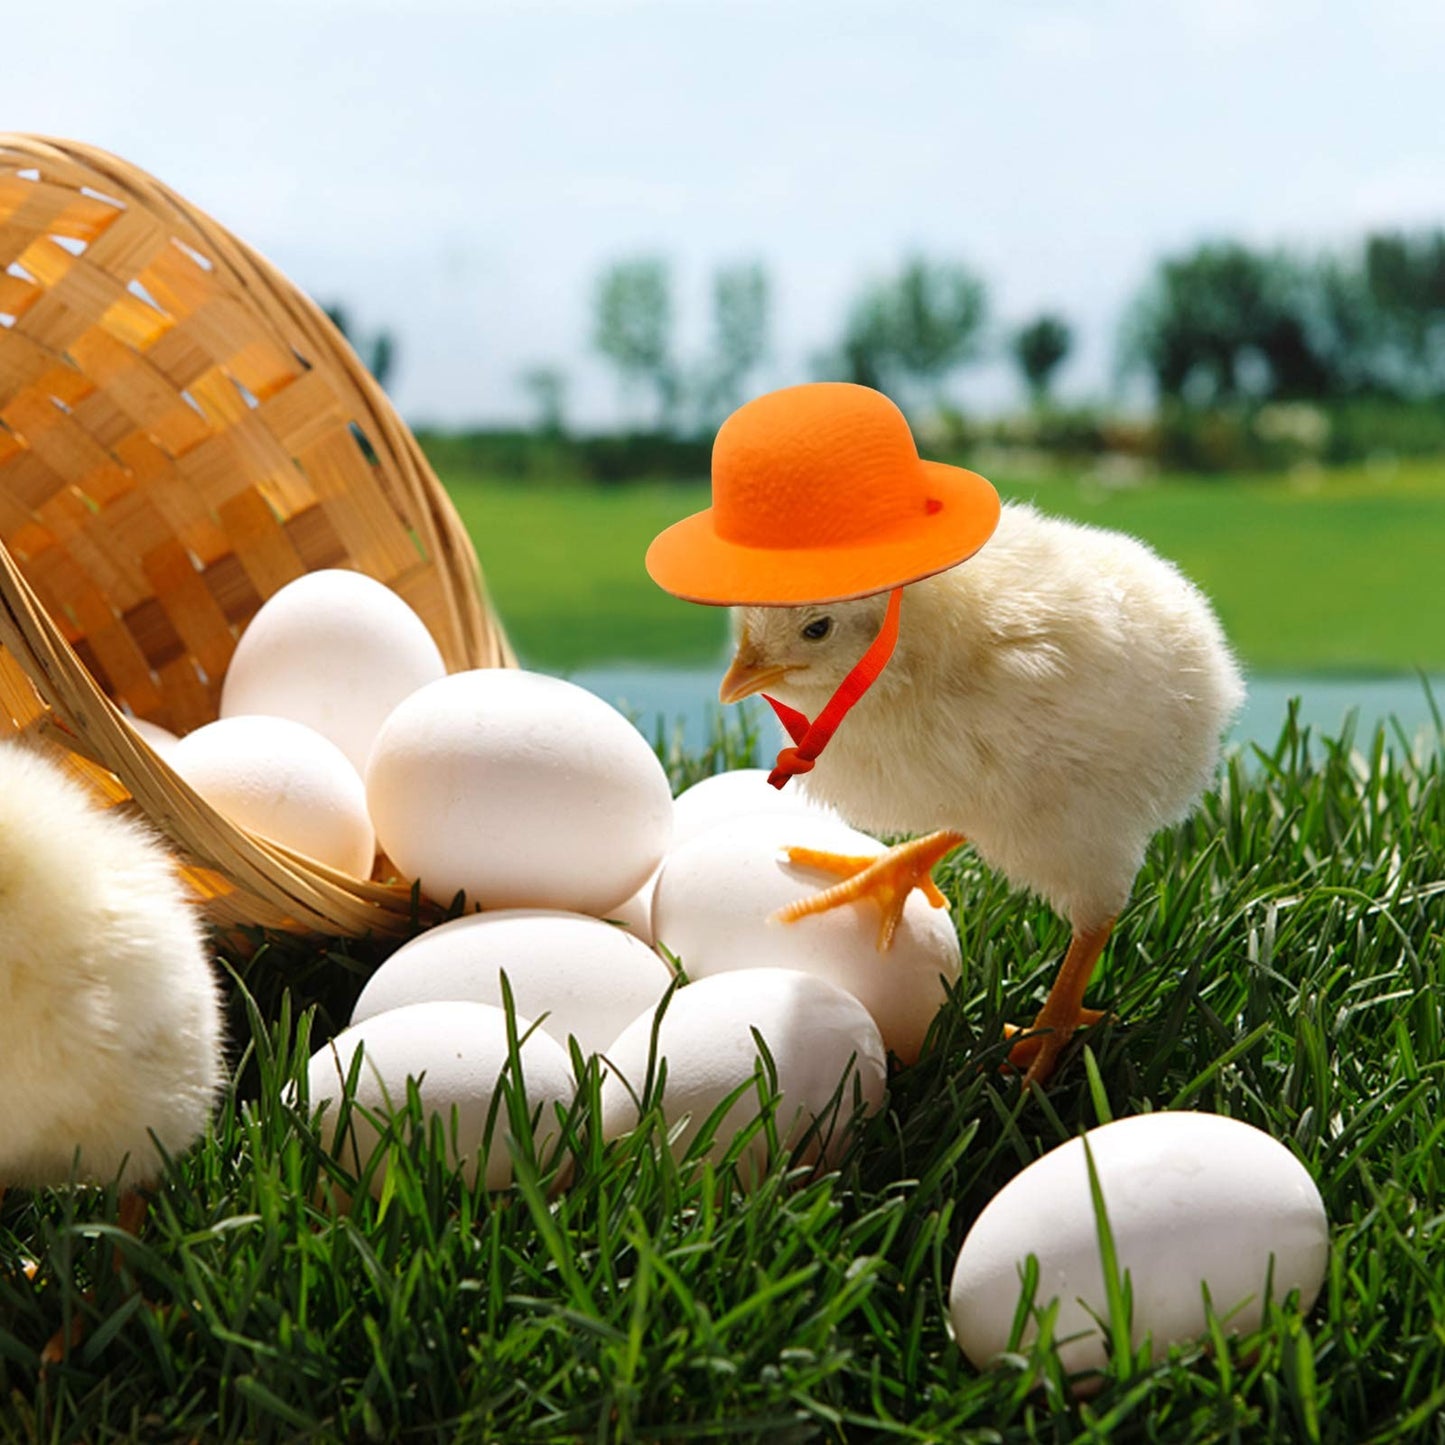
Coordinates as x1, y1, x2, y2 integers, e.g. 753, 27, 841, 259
718, 592, 889, 715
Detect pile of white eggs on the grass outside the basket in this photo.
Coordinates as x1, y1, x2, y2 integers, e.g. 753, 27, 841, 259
299, 770, 959, 1189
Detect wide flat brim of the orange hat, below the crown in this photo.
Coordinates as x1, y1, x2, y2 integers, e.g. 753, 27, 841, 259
646, 461, 1000, 607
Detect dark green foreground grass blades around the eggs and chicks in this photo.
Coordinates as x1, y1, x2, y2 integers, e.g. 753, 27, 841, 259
0, 708, 1445, 1445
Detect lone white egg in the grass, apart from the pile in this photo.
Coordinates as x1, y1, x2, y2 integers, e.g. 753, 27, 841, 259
949, 1113, 1329, 1371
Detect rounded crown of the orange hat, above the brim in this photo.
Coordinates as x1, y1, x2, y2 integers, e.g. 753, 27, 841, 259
712, 381, 936, 548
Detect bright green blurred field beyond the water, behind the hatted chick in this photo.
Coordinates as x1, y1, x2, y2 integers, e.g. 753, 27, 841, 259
444, 462, 1445, 673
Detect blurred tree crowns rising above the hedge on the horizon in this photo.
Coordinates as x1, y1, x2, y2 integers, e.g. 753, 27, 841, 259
523, 231, 1445, 435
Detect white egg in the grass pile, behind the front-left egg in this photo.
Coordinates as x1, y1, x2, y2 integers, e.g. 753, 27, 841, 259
351, 909, 672, 1053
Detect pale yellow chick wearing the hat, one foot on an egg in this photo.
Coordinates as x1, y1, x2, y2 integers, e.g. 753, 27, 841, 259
720, 504, 1244, 1082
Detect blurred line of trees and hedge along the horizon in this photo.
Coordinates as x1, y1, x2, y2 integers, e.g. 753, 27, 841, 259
331, 230, 1445, 481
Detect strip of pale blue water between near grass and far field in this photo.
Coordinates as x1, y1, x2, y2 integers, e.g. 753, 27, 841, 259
572, 662, 1445, 750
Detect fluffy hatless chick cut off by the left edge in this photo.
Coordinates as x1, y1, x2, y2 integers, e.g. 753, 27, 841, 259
0, 744, 221, 1189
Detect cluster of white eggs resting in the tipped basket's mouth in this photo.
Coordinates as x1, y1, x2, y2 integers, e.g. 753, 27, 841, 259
147, 571, 672, 913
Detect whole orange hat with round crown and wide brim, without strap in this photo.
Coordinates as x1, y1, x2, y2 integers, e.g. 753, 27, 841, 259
646, 381, 998, 607
